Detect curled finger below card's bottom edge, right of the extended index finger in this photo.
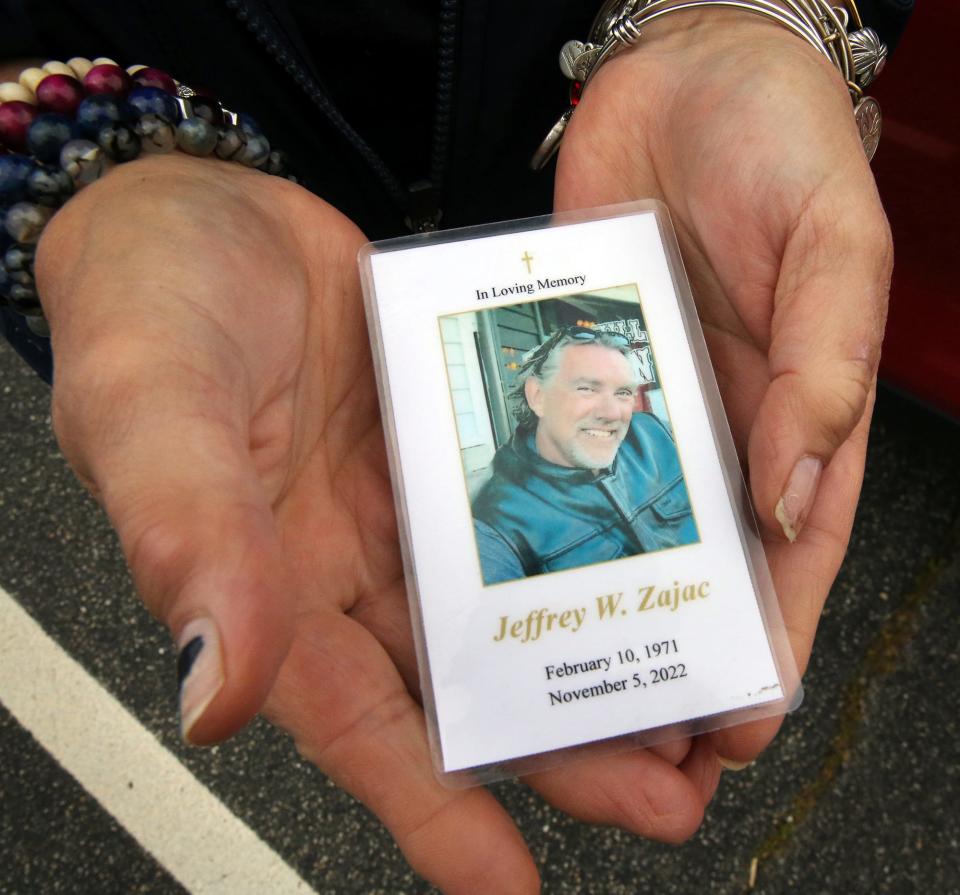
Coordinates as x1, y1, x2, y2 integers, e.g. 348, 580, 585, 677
524, 749, 705, 845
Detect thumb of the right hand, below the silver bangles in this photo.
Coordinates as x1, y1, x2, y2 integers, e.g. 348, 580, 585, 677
748, 188, 893, 541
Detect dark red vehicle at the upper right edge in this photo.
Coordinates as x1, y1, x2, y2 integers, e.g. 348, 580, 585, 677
871, 0, 960, 419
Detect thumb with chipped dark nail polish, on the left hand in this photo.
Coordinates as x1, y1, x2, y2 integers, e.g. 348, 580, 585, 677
54, 333, 293, 744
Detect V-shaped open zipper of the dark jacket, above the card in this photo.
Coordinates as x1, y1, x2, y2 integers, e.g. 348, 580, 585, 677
226, 0, 459, 233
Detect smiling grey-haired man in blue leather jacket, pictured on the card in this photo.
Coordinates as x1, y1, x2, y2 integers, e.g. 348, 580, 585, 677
473, 326, 699, 584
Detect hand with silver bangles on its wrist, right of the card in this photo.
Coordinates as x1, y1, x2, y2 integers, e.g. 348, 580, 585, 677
555, 10, 892, 762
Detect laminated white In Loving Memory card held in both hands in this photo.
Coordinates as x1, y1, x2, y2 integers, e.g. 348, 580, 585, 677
360, 202, 800, 785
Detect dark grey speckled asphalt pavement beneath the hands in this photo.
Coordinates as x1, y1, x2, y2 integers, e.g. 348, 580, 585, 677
0, 336, 960, 895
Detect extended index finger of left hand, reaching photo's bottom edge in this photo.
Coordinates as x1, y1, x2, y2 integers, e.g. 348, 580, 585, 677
267, 610, 539, 895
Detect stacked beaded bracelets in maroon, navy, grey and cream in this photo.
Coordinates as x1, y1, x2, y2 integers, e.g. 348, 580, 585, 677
0, 57, 297, 336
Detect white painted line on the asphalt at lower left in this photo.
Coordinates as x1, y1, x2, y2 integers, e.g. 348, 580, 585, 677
0, 589, 314, 895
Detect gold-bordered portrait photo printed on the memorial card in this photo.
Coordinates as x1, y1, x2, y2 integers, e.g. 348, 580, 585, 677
439, 284, 700, 585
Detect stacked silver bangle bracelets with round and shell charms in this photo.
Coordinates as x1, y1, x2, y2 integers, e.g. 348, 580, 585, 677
530, 0, 887, 170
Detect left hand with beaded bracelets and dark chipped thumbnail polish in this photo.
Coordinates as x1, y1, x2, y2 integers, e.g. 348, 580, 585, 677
37, 154, 718, 895
